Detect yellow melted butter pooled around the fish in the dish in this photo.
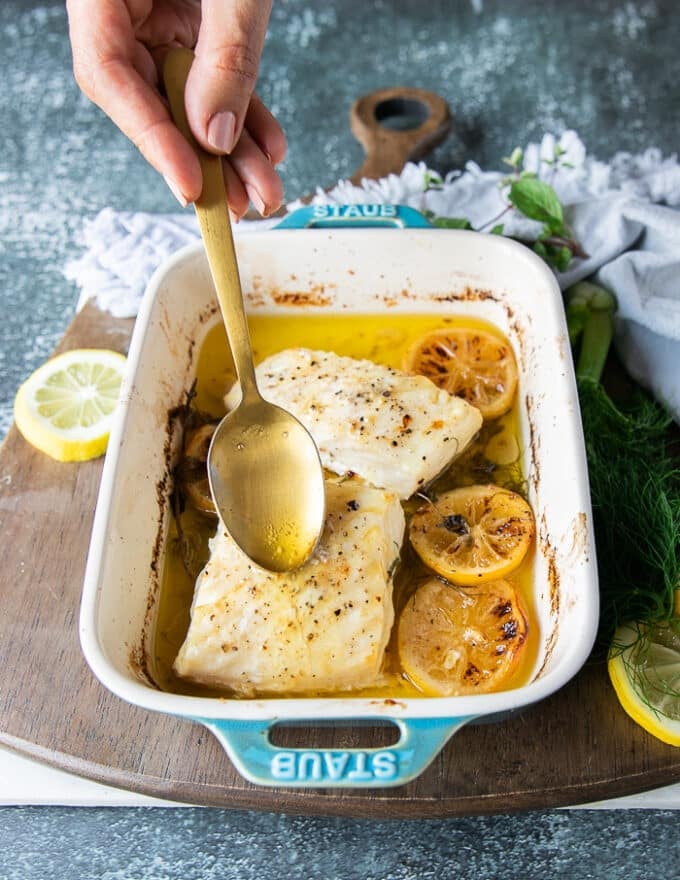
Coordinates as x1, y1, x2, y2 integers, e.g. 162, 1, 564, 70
151, 314, 539, 699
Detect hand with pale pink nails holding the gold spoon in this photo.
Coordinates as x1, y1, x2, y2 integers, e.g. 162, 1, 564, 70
66, 0, 286, 218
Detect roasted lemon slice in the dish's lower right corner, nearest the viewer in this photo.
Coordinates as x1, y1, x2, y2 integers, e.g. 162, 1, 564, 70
397, 578, 527, 696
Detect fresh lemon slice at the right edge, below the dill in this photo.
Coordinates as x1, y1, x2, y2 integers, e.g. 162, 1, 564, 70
607, 621, 680, 746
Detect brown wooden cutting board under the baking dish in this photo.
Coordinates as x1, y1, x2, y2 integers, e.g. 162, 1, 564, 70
0, 90, 680, 818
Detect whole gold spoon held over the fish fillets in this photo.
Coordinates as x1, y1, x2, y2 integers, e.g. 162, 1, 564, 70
163, 49, 325, 572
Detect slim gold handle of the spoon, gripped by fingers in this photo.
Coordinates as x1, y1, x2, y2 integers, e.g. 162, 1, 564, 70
163, 49, 259, 400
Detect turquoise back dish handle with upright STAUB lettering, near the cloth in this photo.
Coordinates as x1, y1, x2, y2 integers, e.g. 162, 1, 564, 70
274, 204, 432, 229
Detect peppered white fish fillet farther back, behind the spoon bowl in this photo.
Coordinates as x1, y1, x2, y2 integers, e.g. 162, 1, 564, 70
226, 348, 482, 498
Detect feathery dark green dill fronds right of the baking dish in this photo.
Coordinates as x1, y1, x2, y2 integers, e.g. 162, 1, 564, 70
578, 379, 680, 650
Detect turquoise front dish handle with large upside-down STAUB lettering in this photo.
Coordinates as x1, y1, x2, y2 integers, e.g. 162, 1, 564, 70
194, 716, 474, 788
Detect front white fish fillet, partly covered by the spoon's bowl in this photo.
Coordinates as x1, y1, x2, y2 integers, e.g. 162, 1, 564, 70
175, 478, 405, 696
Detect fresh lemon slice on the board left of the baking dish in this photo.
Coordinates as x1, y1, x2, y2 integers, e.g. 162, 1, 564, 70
14, 349, 125, 461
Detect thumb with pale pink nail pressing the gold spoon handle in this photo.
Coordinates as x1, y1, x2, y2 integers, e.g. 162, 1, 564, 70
186, 0, 271, 153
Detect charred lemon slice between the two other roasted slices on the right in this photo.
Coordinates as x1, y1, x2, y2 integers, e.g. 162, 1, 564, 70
409, 485, 535, 586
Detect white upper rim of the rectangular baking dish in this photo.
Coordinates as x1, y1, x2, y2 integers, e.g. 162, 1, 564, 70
79, 229, 599, 723
